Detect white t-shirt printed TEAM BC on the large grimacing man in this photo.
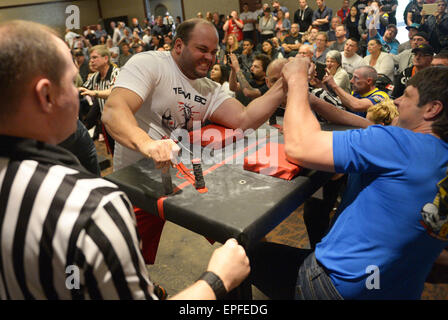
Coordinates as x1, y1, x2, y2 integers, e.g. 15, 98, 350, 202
114, 51, 231, 170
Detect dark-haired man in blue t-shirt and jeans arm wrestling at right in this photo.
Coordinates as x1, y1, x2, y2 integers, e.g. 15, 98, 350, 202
250, 57, 448, 299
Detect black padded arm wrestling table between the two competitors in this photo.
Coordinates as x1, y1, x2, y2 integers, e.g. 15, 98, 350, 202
105, 125, 354, 299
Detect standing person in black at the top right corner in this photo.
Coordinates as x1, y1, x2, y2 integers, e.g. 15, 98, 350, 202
422, 0, 448, 53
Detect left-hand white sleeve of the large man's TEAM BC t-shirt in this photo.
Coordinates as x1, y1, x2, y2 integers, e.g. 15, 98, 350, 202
114, 54, 159, 101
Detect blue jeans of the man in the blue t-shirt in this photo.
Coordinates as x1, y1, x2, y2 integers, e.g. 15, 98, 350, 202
248, 242, 343, 300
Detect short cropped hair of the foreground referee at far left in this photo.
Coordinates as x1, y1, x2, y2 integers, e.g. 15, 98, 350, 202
0, 20, 66, 121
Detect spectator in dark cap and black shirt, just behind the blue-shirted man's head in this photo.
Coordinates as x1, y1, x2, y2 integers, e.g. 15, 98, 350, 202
392, 44, 434, 98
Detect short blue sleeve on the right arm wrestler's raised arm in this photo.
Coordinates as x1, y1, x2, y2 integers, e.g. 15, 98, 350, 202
333, 125, 410, 173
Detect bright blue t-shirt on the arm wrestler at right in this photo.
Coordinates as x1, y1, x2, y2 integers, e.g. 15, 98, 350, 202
315, 125, 448, 299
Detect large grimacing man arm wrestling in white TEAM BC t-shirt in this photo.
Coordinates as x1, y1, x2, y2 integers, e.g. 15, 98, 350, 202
102, 19, 285, 263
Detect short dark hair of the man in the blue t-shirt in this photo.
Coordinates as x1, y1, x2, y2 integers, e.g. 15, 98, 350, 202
407, 66, 448, 142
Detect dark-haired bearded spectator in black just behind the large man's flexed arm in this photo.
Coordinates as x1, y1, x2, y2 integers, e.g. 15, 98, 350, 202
229, 54, 271, 104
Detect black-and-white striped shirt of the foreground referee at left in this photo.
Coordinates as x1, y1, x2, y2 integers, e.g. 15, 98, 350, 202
0, 136, 156, 299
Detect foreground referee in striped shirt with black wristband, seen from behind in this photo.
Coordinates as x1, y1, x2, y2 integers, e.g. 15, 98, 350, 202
0, 20, 249, 300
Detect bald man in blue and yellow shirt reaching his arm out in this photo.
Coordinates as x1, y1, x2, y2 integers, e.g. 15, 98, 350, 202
323, 66, 390, 117
